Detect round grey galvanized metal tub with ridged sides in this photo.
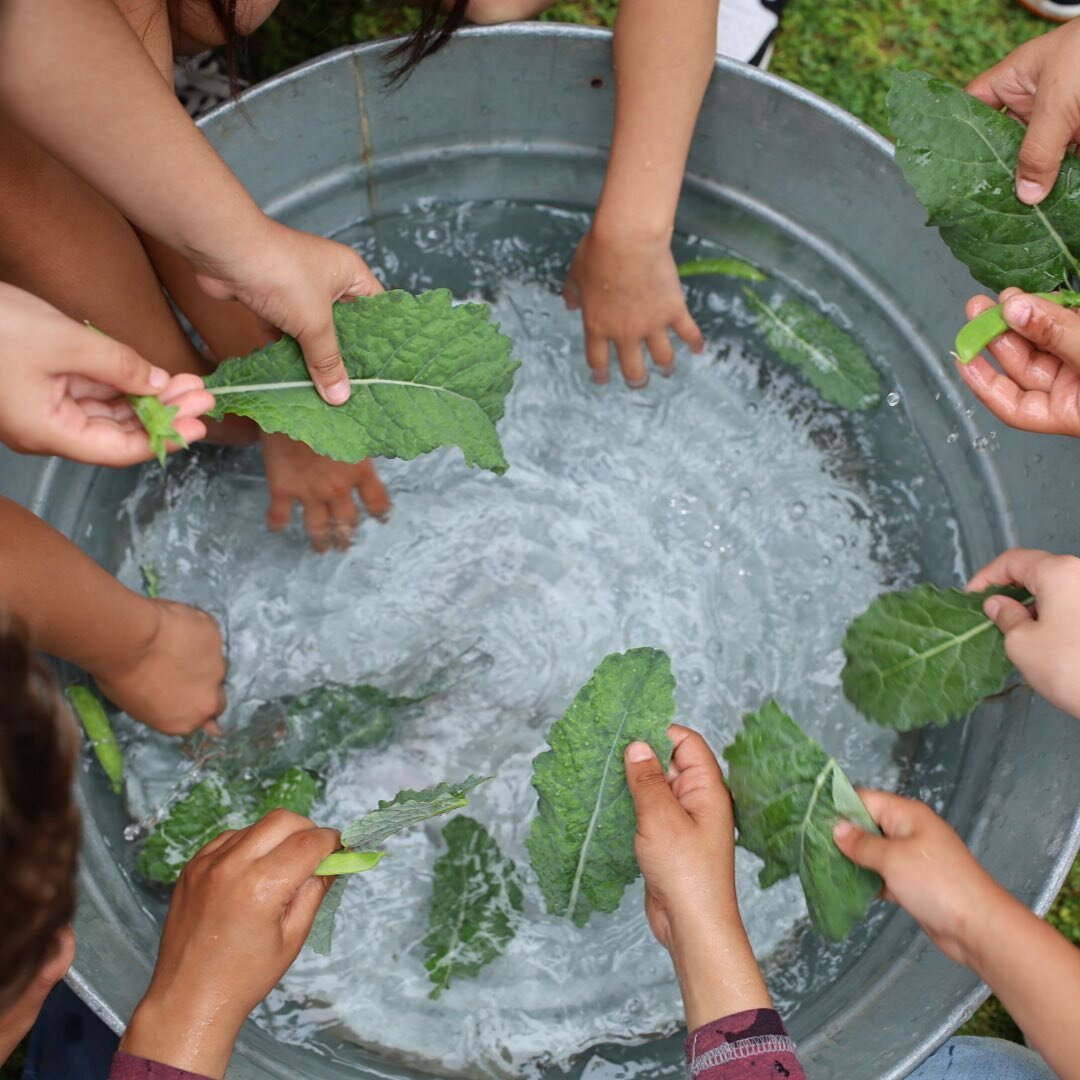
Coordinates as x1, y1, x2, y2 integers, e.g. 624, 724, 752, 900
0, 25, 1080, 1080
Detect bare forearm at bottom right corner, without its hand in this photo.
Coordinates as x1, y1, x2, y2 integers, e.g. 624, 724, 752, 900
967, 889, 1080, 1080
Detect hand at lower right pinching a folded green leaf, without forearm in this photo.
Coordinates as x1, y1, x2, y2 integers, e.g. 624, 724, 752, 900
833, 788, 1004, 966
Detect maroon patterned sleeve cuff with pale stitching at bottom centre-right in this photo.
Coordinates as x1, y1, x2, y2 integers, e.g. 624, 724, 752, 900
684, 1009, 806, 1080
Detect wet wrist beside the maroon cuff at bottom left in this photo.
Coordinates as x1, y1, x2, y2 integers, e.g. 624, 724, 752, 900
120, 991, 243, 1080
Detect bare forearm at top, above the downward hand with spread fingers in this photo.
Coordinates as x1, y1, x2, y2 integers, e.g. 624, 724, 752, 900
594, 0, 718, 238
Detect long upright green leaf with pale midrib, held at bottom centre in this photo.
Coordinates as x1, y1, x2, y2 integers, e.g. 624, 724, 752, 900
526, 649, 675, 927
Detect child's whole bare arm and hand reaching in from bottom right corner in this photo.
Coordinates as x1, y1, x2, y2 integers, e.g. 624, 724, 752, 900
834, 791, 1080, 1080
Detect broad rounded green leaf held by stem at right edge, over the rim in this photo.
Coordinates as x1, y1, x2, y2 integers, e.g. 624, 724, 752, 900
841, 584, 1031, 731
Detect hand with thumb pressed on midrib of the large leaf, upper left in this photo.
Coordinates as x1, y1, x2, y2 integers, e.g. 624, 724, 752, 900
195, 218, 382, 405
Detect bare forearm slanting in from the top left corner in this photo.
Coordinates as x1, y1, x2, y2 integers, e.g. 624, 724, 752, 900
0, 0, 267, 272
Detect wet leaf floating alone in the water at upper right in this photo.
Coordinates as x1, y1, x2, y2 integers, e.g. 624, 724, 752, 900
743, 288, 881, 410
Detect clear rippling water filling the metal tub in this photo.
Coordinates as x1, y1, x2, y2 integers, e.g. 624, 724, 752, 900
107, 200, 960, 1077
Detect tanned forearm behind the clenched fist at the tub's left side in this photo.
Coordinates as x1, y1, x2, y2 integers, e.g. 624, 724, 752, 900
0, 499, 157, 674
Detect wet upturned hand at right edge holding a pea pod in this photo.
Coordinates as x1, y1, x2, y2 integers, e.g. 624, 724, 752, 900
957, 291, 1080, 437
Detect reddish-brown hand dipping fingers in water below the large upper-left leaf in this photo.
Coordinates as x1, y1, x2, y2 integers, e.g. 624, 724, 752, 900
259, 434, 390, 552
